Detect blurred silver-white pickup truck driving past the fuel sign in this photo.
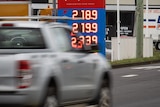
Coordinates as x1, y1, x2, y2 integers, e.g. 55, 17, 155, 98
0, 21, 111, 107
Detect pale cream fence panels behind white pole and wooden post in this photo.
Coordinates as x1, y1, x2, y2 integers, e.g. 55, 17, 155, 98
111, 37, 153, 61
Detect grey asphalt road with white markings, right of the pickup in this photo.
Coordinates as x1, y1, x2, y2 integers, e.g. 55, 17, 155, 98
111, 63, 160, 107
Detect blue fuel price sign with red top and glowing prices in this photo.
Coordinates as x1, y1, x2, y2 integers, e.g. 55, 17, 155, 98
58, 0, 106, 55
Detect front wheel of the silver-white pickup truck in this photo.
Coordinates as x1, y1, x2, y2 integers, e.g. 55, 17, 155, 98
98, 80, 111, 107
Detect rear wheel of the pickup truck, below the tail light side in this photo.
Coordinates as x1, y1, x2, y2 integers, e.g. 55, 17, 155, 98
43, 86, 58, 107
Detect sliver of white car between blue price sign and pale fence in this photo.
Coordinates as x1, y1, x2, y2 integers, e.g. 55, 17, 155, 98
105, 40, 113, 60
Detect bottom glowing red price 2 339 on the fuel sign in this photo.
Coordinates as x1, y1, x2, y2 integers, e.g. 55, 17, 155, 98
71, 35, 98, 48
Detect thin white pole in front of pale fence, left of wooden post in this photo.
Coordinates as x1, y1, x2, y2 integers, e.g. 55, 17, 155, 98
117, 0, 120, 60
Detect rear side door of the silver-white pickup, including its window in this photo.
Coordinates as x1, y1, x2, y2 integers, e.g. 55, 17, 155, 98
48, 27, 92, 102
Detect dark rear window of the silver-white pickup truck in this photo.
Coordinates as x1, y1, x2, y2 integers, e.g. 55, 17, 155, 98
0, 28, 45, 49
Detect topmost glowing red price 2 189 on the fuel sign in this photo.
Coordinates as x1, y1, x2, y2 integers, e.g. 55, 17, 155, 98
72, 10, 98, 20
